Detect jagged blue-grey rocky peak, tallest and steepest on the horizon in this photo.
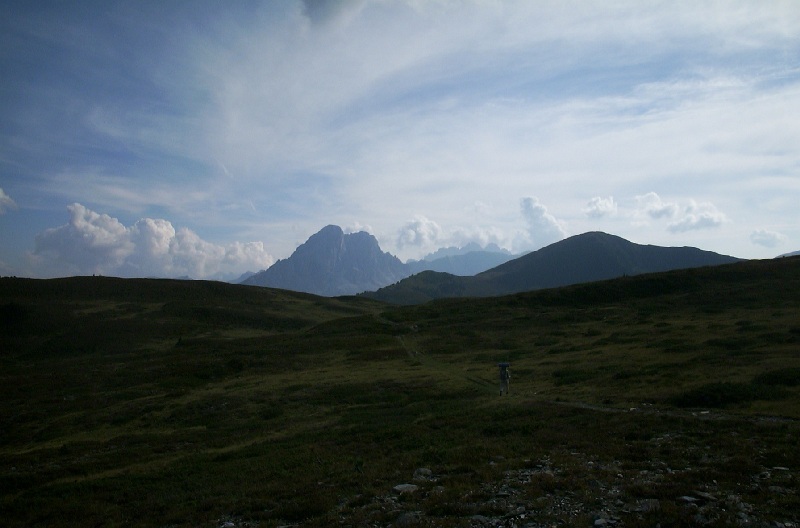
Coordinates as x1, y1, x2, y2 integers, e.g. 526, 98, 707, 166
243, 225, 408, 297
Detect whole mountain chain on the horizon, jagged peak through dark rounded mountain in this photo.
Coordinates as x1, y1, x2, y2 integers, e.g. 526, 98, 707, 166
241, 225, 739, 304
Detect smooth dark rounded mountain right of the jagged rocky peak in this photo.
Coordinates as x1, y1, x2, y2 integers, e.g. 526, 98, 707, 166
364, 232, 740, 304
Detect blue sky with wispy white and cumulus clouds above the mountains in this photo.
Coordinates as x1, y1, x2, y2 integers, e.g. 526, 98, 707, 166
0, 0, 800, 278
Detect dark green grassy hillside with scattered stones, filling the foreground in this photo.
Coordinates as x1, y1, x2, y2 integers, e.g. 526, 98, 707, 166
0, 258, 800, 527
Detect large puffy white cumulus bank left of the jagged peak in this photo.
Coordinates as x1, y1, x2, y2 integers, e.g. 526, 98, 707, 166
33, 203, 274, 278
